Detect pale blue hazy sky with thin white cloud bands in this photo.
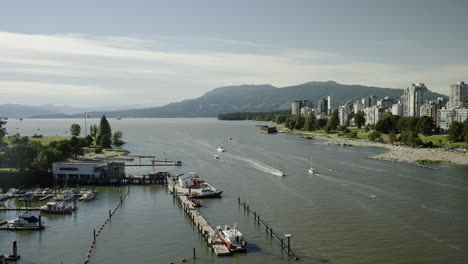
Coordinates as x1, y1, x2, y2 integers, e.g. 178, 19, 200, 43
0, 0, 468, 106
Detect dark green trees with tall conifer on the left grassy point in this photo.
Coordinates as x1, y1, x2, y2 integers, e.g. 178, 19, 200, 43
70, 115, 125, 148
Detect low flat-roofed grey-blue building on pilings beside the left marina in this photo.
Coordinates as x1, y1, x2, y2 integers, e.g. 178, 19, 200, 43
52, 160, 125, 182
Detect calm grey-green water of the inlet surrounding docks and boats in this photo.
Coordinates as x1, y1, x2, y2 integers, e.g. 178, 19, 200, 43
0, 119, 468, 264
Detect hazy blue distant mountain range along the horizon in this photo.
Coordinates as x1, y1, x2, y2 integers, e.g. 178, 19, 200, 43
6, 81, 447, 118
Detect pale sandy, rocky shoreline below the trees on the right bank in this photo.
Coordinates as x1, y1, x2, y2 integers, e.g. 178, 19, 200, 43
279, 127, 468, 169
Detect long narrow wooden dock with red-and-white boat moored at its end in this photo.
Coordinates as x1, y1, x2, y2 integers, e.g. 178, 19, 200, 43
167, 182, 231, 256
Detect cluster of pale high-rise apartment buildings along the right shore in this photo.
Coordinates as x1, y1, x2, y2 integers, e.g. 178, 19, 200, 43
291, 82, 468, 130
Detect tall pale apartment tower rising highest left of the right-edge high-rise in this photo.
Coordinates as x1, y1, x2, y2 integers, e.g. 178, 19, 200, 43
403, 83, 427, 117
